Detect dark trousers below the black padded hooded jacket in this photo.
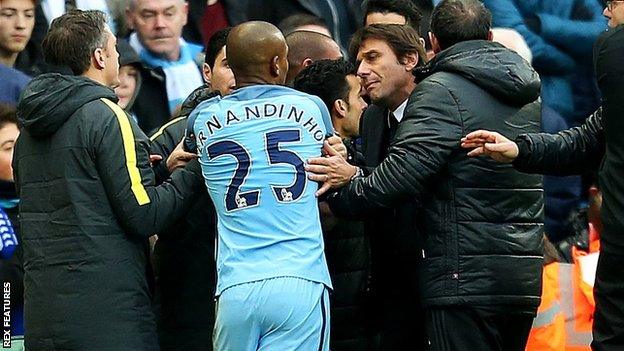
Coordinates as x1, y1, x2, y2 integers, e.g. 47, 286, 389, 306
427, 306, 534, 351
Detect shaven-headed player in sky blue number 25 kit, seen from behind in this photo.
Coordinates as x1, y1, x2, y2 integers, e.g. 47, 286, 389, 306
189, 22, 332, 351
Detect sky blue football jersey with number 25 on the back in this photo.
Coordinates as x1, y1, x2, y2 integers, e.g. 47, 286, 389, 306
189, 85, 333, 295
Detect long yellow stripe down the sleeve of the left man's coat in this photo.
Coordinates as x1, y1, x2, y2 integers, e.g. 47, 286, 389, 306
100, 98, 150, 205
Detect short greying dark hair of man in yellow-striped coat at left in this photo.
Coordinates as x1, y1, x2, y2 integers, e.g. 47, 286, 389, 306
41, 10, 108, 75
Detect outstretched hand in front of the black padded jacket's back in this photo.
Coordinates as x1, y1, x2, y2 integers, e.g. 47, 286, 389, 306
461, 130, 519, 163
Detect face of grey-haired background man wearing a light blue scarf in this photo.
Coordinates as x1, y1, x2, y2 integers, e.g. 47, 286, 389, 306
127, 0, 188, 61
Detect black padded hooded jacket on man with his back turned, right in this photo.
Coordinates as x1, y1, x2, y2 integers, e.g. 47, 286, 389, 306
330, 41, 543, 312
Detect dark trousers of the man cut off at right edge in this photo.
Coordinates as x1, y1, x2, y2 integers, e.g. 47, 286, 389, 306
592, 246, 624, 351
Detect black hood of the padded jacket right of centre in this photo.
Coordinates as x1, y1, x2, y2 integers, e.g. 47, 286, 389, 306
414, 40, 540, 106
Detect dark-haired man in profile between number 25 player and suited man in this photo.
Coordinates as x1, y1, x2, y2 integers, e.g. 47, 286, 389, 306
294, 59, 375, 351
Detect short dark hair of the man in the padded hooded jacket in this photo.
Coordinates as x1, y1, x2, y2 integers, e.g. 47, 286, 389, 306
431, 0, 492, 50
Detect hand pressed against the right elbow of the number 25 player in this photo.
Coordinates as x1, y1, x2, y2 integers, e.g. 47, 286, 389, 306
305, 140, 357, 196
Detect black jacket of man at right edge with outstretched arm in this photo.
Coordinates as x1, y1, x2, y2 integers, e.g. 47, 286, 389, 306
514, 25, 624, 254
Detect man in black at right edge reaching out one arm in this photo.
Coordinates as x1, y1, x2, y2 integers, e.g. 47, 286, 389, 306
462, 22, 624, 350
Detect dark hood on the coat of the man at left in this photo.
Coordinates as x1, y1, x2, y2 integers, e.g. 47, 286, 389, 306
17, 73, 117, 137
